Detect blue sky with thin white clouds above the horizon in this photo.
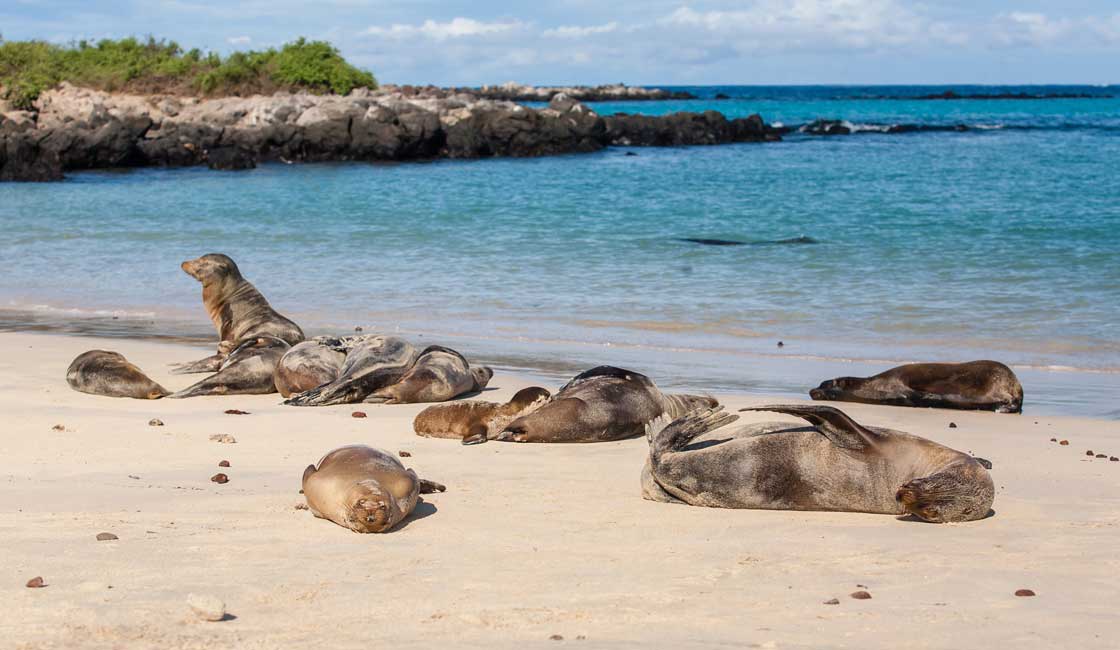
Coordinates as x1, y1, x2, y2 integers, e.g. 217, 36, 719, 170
0, 0, 1120, 85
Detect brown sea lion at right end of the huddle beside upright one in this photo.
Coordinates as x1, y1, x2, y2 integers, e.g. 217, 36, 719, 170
365, 345, 494, 403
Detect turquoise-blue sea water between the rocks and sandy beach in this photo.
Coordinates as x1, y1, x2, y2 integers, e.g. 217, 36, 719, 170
0, 86, 1120, 417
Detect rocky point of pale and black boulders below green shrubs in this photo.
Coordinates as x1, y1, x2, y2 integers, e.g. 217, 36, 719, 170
0, 83, 782, 180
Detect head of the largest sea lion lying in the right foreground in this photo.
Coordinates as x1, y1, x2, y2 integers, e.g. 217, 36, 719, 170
895, 459, 996, 523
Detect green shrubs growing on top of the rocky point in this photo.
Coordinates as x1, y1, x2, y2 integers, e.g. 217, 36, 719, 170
0, 37, 377, 110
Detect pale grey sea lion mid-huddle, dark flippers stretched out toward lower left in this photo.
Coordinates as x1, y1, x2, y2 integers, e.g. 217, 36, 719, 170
283, 335, 417, 406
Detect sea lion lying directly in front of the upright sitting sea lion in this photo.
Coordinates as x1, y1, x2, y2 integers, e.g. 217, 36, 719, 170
169, 336, 290, 399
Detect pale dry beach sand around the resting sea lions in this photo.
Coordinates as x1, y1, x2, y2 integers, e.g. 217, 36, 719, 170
0, 334, 1120, 649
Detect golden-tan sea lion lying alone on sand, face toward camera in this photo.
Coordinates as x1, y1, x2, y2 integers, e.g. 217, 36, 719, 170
304, 445, 447, 532
